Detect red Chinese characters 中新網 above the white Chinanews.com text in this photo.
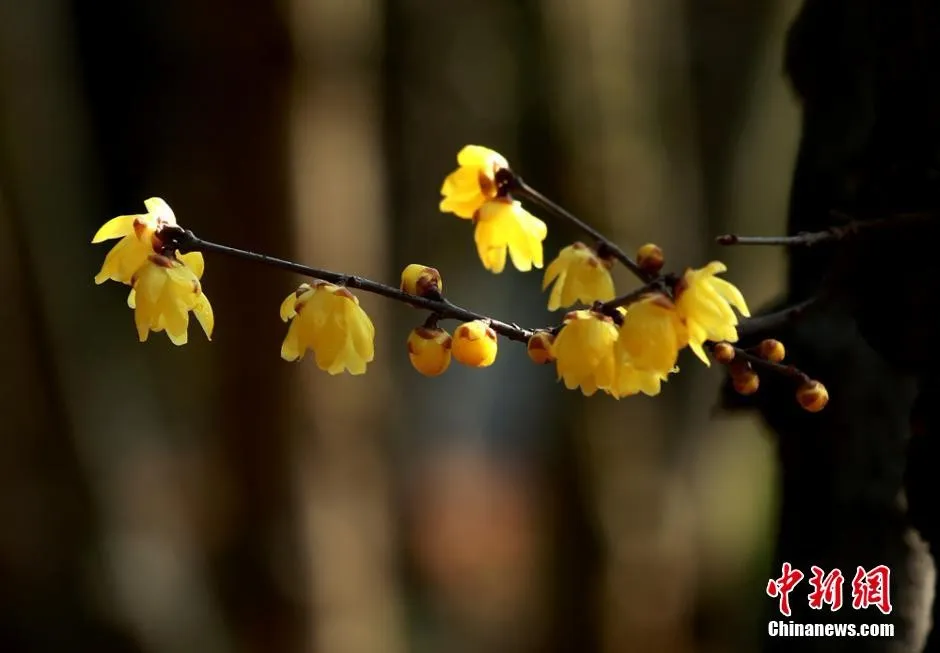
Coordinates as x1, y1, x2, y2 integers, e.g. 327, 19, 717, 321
767, 562, 892, 617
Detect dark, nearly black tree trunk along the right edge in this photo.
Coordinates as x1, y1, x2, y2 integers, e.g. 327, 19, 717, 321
726, 0, 940, 651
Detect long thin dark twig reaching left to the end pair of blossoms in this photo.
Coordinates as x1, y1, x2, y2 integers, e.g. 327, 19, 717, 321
160, 227, 533, 342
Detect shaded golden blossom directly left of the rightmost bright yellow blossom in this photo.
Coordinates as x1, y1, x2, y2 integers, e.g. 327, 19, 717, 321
617, 293, 689, 377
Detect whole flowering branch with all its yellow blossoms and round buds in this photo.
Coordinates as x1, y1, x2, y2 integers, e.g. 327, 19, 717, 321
92, 145, 828, 412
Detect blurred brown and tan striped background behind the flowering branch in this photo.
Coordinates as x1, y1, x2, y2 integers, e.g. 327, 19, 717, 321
0, 0, 800, 653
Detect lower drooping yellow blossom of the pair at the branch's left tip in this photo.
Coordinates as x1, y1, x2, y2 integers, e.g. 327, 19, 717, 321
127, 252, 215, 345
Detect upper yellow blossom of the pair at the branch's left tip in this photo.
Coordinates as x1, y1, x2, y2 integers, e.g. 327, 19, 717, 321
91, 197, 176, 285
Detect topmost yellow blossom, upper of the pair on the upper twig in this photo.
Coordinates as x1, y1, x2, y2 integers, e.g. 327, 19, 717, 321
440, 145, 509, 220
